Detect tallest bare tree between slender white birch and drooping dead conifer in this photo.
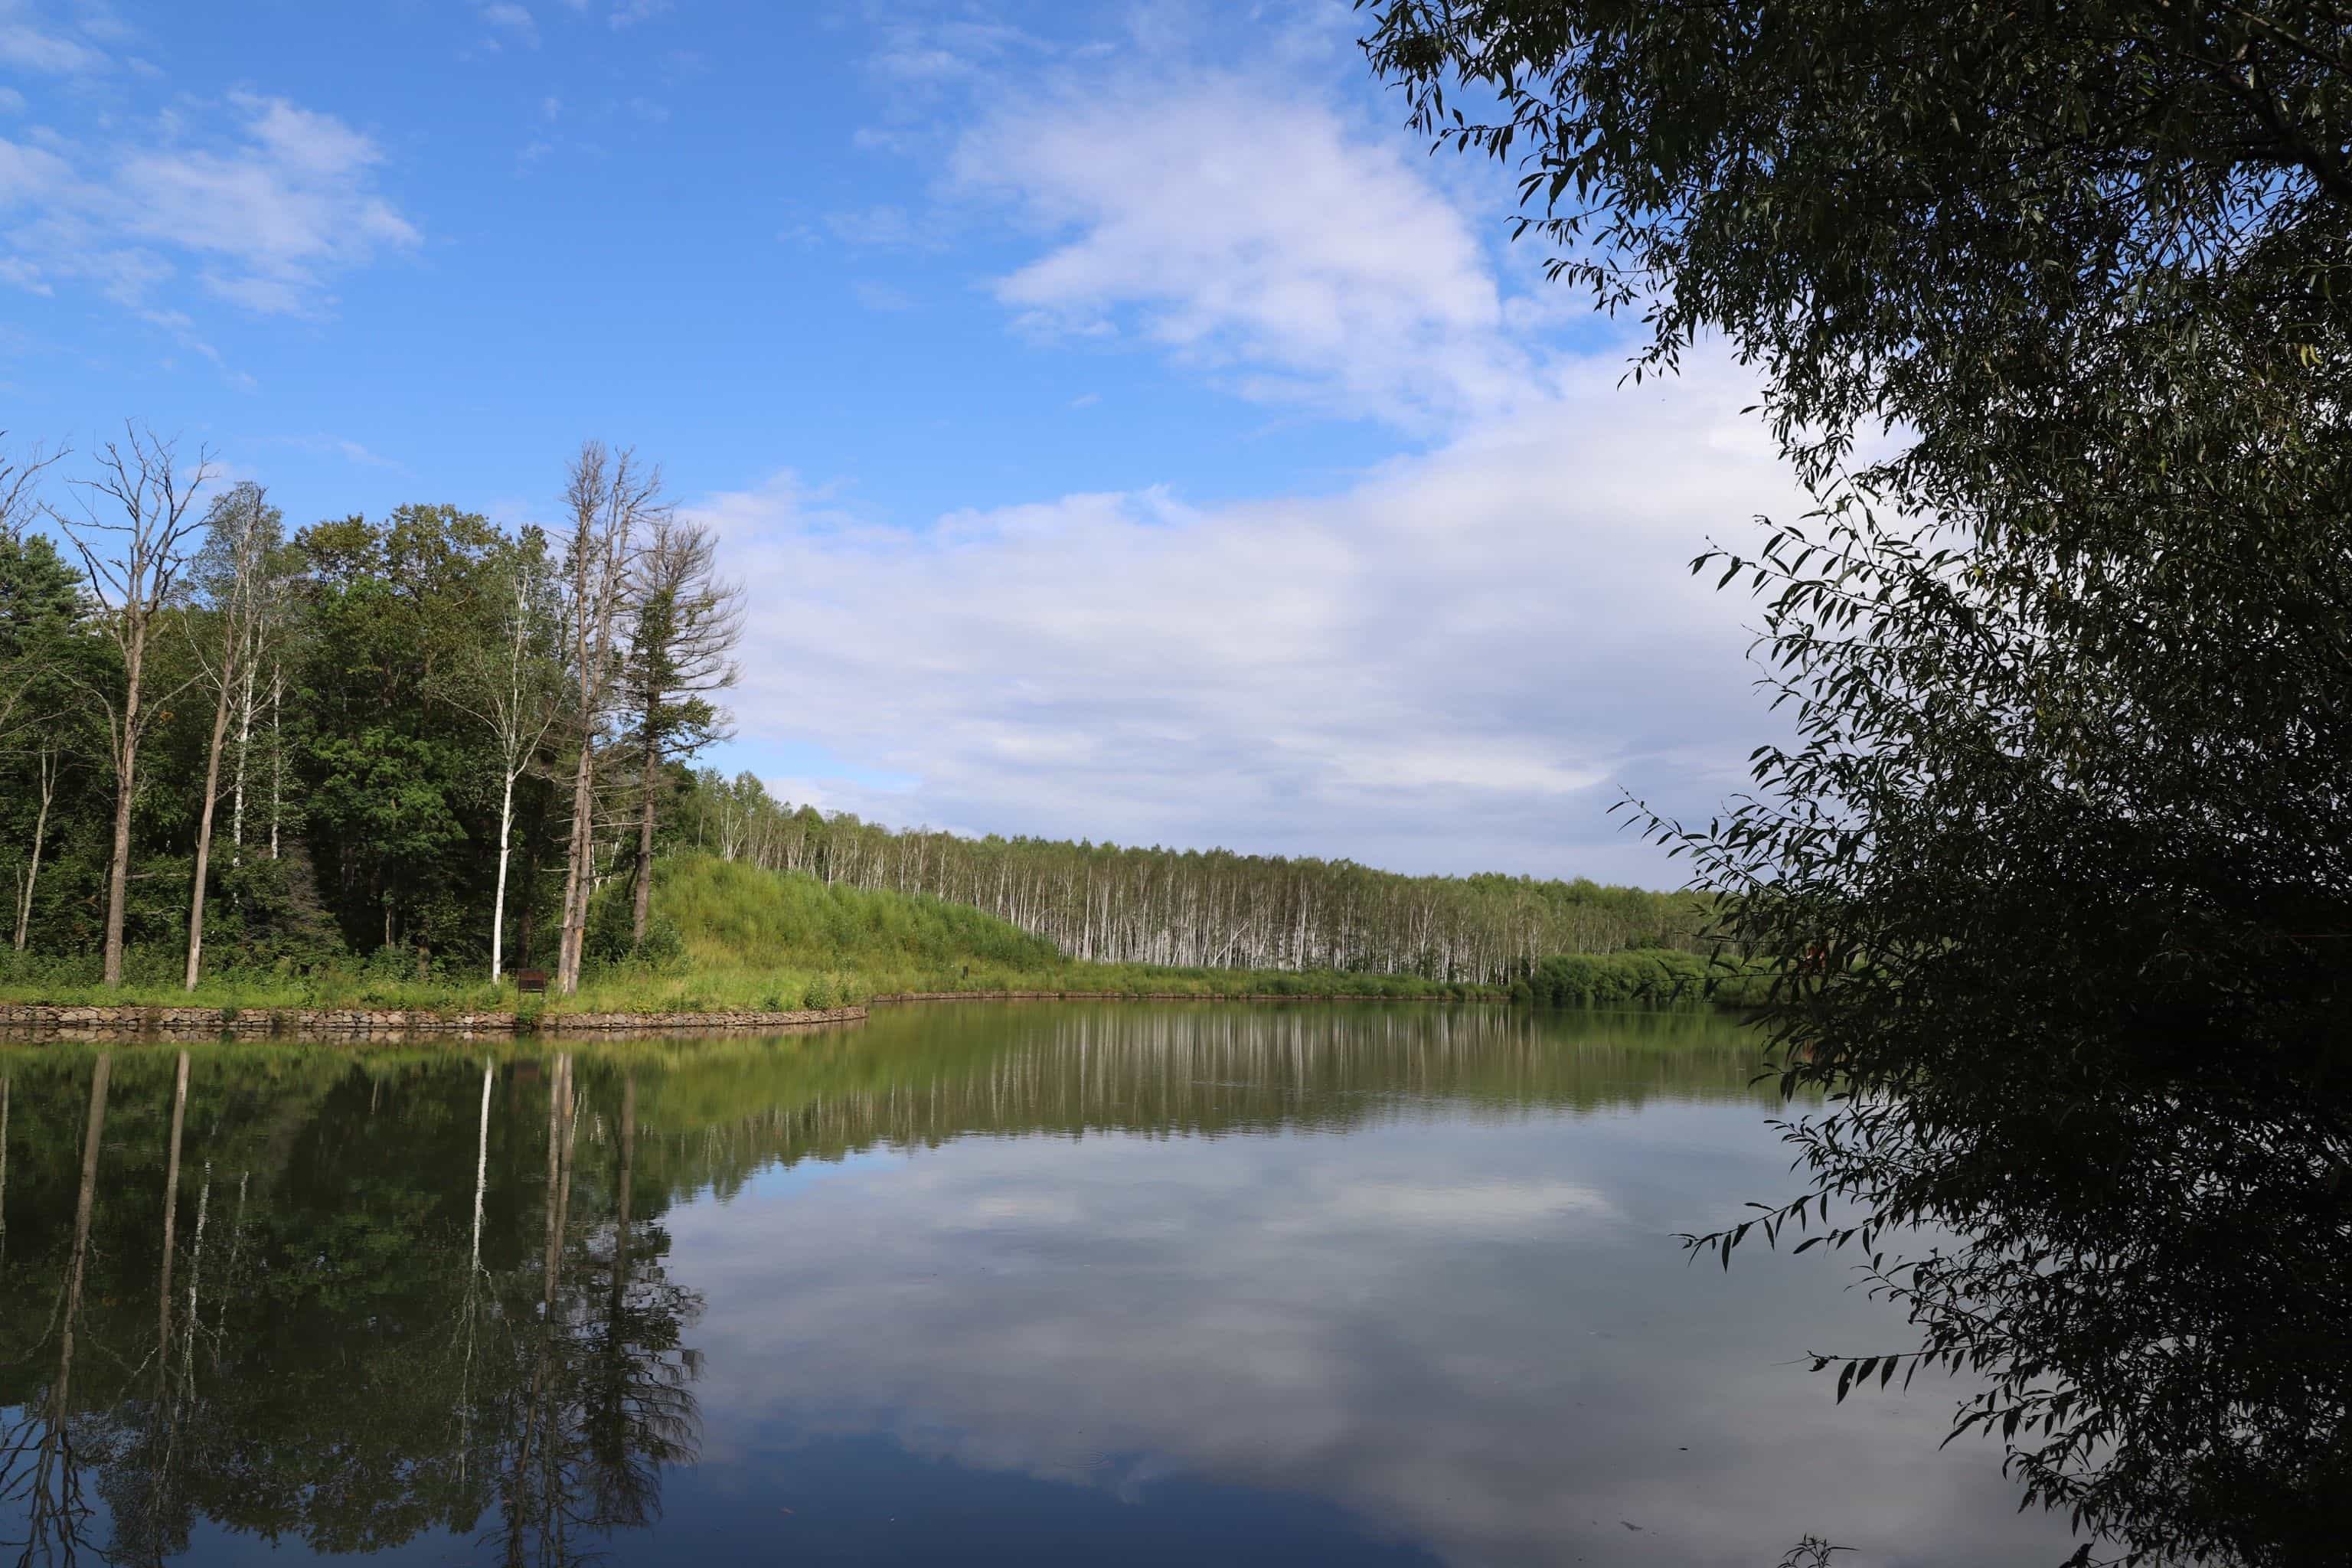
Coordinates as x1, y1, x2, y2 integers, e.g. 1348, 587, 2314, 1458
555, 442, 668, 997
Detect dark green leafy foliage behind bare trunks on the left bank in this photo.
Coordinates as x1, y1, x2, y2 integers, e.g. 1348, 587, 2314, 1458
0, 501, 576, 978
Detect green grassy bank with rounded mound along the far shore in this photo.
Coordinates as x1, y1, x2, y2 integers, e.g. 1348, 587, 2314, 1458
0, 856, 1769, 1013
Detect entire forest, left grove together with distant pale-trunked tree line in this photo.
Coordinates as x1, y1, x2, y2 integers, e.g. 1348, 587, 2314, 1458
0, 428, 1707, 992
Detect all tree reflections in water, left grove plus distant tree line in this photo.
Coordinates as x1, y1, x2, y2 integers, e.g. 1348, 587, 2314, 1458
0, 1008, 1750, 1563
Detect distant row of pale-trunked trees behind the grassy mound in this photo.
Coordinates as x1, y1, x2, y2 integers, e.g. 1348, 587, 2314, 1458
678, 769, 1717, 985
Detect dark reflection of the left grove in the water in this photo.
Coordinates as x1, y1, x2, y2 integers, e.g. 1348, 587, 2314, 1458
0, 1048, 701, 1566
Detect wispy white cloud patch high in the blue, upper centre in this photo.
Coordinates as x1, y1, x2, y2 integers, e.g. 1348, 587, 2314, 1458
952, 75, 1534, 423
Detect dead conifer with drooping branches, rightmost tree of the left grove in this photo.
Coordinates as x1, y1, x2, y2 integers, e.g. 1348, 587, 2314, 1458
628, 512, 743, 942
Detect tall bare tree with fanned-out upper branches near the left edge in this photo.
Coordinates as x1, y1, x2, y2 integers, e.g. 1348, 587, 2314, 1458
50, 423, 214, 985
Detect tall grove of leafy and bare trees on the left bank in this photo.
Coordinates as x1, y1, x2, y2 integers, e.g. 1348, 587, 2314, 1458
0, 426, 741, 992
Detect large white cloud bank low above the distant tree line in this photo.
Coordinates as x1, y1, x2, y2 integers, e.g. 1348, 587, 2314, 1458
694, 358, 1788, 884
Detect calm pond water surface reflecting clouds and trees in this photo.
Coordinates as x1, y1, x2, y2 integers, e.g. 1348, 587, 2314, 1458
0, 1004, 2067, 1568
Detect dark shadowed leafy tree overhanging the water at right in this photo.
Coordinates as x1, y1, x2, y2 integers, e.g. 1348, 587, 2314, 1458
1371, 0, 2352, 1563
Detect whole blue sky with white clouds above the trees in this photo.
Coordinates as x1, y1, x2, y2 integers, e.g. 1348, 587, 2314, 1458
0, 0, 1790, 884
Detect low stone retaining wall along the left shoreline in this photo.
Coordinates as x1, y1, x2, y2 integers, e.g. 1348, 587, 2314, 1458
0, 1004, 865, 1039
